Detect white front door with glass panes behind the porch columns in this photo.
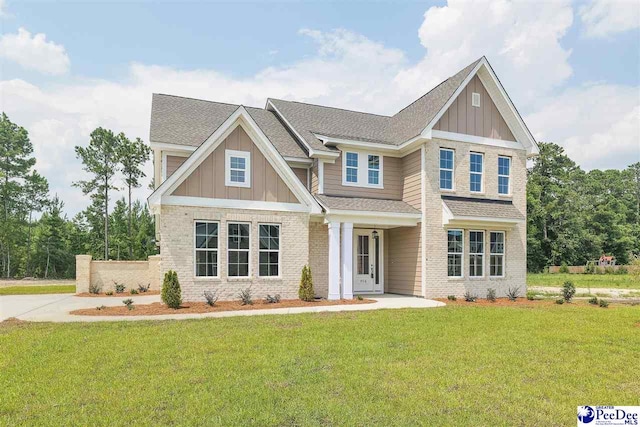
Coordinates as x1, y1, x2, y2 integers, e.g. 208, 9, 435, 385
353, 230, 383, 293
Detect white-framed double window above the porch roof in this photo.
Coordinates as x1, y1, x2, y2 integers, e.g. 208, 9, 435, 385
342, 151, 384, 188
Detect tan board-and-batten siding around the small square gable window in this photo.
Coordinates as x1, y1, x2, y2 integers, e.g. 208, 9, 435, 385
173, 127, 300, 203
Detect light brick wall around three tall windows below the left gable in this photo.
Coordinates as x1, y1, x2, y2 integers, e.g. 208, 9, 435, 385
160, 206, 315, 301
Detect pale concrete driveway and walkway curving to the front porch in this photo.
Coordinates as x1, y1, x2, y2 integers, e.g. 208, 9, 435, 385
0, 294, 445, 322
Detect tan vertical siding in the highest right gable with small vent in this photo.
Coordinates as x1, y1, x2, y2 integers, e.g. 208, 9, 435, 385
434, 76, 516, 141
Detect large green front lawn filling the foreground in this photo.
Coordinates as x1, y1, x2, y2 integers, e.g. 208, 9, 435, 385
0, 303, 640, 426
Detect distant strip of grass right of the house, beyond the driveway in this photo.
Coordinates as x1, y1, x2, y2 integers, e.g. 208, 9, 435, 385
527, 273, 640, 289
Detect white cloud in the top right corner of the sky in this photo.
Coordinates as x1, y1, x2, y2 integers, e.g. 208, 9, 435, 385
580, 0, 640, 37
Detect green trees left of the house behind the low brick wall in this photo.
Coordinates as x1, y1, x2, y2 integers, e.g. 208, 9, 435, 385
0, 113, 157, 278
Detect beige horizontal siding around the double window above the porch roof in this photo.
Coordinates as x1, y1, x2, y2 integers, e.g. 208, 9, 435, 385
324, 154, 402, 200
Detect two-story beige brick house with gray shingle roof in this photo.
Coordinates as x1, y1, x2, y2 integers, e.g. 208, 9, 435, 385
148, 57, 538, 300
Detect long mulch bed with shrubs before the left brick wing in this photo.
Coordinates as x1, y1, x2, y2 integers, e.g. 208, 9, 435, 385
70, 293, 375, 316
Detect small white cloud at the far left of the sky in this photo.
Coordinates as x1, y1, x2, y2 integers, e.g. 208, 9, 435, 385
0, 27, 70, 75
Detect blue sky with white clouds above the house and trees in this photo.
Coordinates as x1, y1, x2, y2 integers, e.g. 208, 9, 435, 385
0, 0, 640, 213
